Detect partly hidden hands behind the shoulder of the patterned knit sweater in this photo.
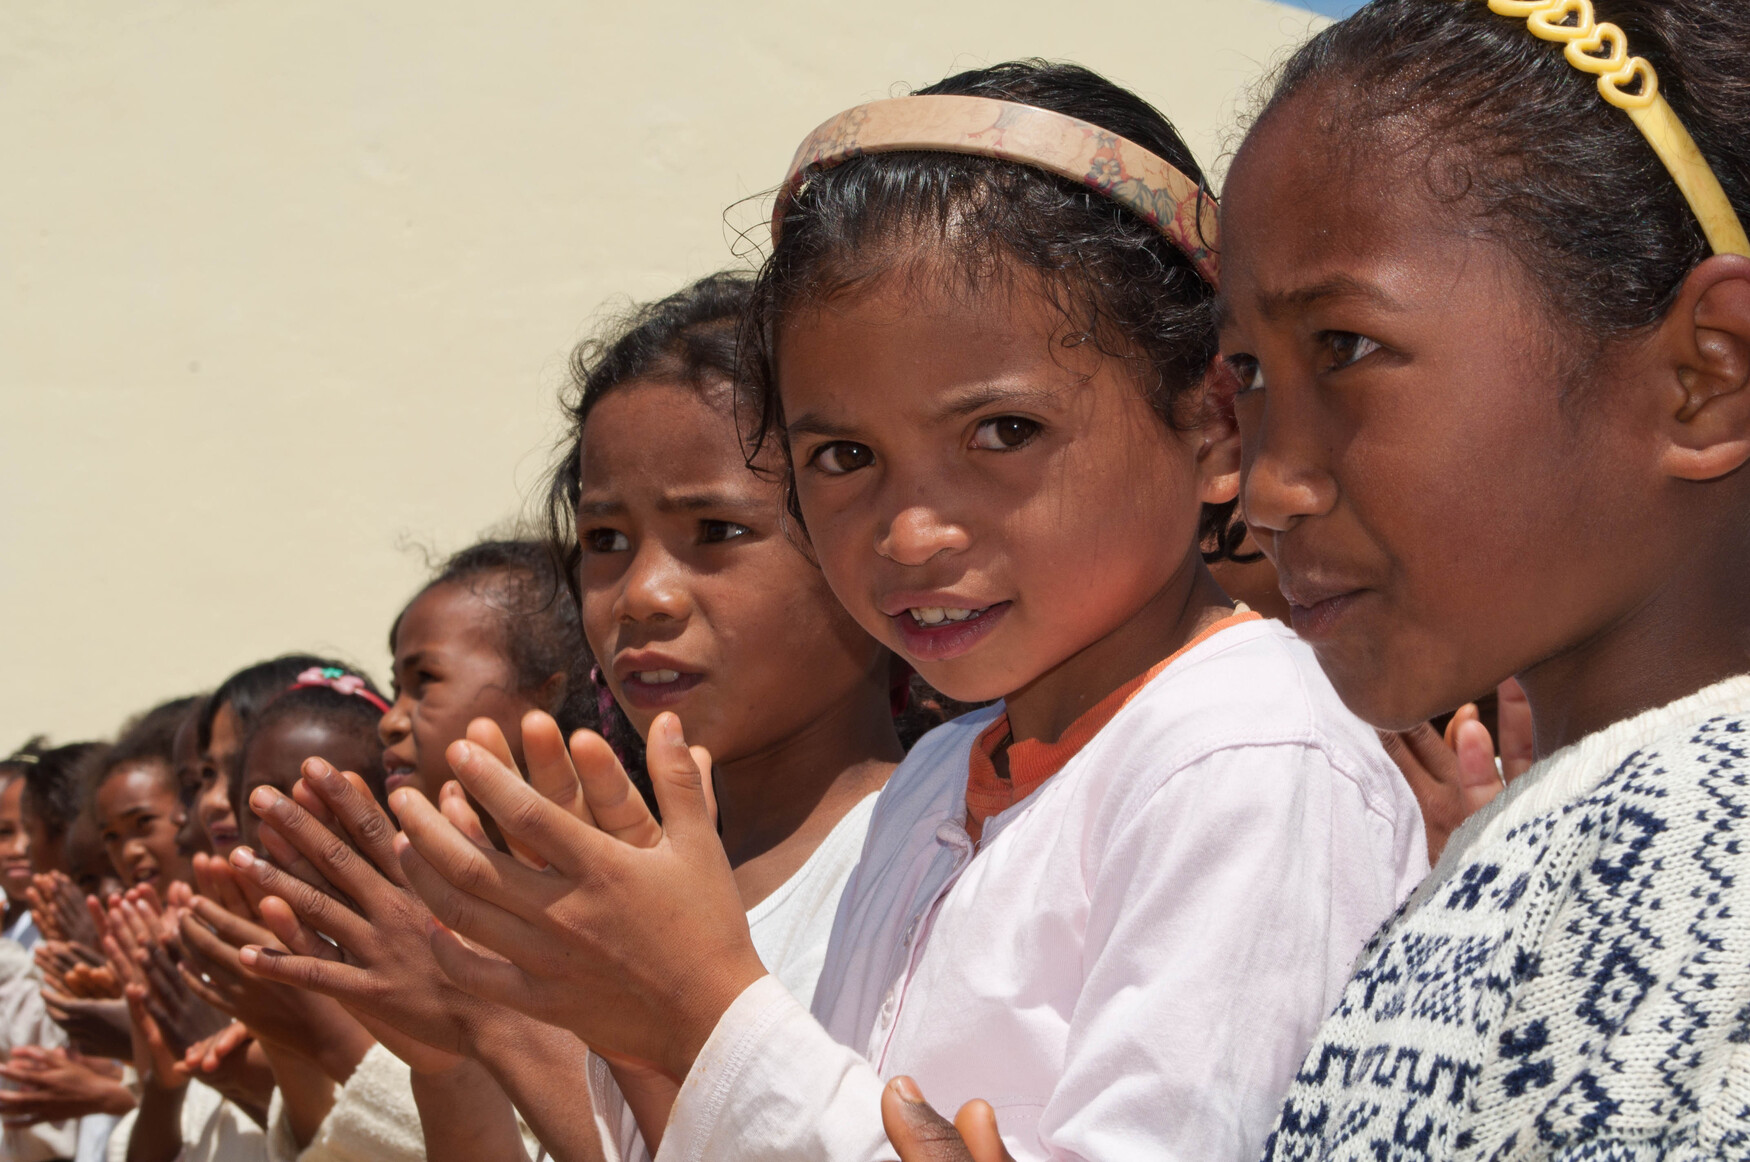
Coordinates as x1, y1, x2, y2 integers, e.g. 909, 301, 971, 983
1379, 679, 1535, 863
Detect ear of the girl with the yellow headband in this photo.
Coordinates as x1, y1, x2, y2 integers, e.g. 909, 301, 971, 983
1659, 254, 1750, 481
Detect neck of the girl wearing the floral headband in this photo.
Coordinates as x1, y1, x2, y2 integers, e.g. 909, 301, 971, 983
1005, 548, 1234, 742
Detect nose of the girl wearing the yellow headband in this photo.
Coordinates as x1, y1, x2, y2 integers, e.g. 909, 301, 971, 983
1234, 387, 1337, 532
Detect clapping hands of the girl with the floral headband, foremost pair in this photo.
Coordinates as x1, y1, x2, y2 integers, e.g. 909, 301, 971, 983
394, 714, 765, 1078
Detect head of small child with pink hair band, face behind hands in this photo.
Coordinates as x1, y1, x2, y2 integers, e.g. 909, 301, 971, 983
233, 669, 389, 852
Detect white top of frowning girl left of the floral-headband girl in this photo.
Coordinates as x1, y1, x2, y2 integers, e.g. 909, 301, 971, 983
590, 793, 880, 1162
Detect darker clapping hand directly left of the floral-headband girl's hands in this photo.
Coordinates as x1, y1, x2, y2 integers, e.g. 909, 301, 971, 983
231, 758, 497, 1073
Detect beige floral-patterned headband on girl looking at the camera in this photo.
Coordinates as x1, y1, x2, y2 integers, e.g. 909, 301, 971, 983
772, 95, 1218, 287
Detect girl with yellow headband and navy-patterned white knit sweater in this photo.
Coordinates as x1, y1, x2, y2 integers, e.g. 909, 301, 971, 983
887, 0, 1750, 1160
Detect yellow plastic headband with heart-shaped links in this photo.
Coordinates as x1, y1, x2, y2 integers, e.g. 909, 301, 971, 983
1488, 0, 1750, 257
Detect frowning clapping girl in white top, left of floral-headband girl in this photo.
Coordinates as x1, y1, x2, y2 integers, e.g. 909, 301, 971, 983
232, 275, 908, 1157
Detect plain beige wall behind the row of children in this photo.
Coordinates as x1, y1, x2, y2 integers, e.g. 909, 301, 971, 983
0, 0, 1318, 738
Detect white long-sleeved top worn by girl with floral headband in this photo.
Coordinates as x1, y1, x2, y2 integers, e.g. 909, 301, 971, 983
658, 621, 1428, 1162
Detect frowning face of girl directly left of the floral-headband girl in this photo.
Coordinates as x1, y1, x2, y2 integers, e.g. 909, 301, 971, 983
578, 380, 887, 763
